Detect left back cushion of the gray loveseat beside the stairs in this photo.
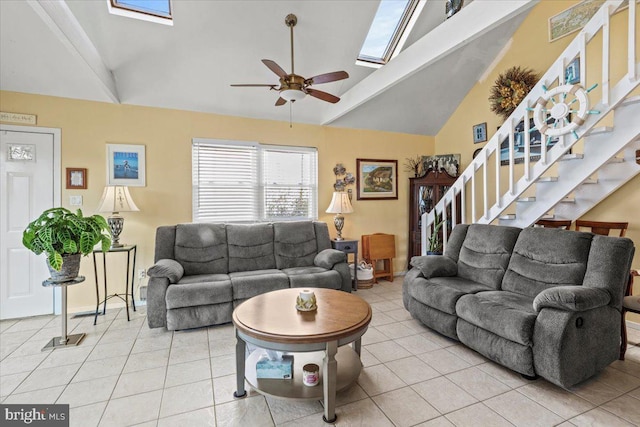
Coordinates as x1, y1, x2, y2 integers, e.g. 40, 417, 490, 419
452, 224, 521, 289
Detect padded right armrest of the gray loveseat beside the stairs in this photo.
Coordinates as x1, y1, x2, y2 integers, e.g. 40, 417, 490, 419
533, 286, 611, 312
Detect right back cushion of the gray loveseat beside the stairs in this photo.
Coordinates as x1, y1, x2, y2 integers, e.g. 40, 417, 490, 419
502, 227, 593, 297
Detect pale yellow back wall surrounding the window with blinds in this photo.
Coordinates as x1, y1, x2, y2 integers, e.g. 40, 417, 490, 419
0, 92, 434, 311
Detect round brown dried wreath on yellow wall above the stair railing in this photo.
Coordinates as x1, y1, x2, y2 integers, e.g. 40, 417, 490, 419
489, 67, 540, 120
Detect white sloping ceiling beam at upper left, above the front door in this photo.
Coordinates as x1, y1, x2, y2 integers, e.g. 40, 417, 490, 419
27, 0, 120, 104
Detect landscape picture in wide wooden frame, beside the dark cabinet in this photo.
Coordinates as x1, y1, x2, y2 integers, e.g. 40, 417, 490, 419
356, 159, 398, 200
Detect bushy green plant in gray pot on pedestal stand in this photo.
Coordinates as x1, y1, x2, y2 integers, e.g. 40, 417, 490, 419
22, 207, 111, 282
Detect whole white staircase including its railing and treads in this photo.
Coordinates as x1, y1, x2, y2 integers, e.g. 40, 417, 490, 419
422, 0, 640, 252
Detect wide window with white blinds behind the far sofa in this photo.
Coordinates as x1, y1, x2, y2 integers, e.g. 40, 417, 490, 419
192, 139, 318, 222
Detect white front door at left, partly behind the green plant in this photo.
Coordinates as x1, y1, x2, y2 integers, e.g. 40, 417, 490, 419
0, 126, 60, 319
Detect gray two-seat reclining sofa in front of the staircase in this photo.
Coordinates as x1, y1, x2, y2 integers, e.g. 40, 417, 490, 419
403, 224, 635, 388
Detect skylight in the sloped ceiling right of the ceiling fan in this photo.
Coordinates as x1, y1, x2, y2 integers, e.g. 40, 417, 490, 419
356, 0, 424, 67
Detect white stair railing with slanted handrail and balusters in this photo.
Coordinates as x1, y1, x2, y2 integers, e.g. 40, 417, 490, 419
421, 0, 640, 255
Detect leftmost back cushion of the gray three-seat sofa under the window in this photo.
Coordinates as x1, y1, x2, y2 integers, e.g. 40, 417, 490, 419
174, 224, 229, 275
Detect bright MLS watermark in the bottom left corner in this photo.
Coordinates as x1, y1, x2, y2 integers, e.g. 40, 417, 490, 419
0, 404, 69, 427
